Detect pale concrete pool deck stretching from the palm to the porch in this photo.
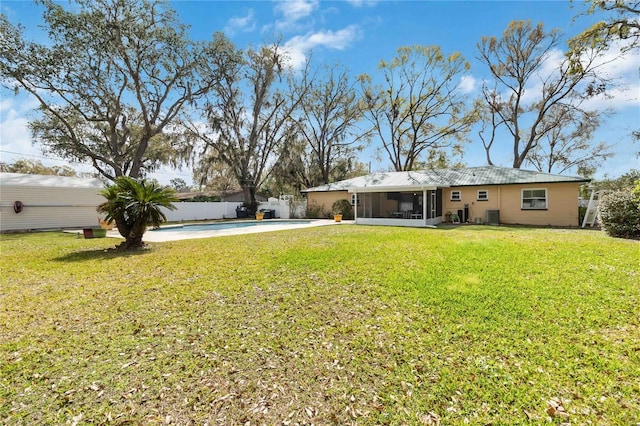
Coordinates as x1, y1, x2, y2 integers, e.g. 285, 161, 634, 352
101, 219, 353, 243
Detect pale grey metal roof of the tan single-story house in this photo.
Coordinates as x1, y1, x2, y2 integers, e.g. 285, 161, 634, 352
302, 166, 590, 192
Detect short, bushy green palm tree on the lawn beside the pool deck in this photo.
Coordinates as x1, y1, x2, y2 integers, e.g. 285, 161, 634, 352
97, 176, 178, 250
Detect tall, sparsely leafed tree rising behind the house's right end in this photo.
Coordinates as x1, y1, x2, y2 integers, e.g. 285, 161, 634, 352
478, 21, 606, 168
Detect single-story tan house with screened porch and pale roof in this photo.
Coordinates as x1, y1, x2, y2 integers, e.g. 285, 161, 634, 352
302, 166, 589, 226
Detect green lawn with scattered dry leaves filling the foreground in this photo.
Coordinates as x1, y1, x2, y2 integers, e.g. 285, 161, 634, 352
0, 225, 640, 425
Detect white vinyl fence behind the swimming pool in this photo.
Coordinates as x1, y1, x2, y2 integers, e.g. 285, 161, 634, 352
162, 198, 291, 222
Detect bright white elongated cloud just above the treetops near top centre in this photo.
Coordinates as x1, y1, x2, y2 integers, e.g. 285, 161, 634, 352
283, 25, 360, 69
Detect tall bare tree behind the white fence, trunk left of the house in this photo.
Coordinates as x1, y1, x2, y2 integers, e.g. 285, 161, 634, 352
190, 44, 307, 204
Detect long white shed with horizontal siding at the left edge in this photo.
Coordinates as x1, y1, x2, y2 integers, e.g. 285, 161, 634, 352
0, 173, 105, 232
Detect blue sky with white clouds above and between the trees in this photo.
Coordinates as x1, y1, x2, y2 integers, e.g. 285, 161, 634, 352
0, 0, 640, 183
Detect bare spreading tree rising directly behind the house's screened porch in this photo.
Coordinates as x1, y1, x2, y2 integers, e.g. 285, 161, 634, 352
359, 46, 476, 171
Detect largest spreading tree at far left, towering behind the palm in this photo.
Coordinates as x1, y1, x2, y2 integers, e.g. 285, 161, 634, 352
0, 0, 227, 179
